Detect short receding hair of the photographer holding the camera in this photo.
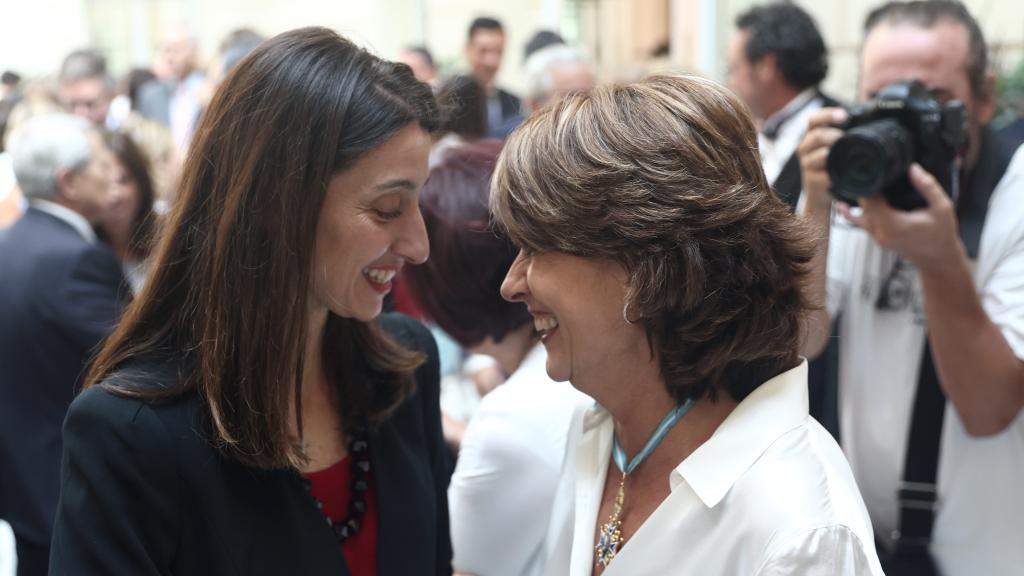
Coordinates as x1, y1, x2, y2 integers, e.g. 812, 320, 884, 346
864, 0, 988, 97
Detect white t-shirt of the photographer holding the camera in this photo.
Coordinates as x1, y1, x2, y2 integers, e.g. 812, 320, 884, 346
828, 148, 1024, 576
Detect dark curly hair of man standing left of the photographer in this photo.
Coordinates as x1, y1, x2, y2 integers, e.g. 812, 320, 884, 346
735, 2, 828, 90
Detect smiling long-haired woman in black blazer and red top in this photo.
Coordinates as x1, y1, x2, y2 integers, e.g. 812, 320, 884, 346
50, 28, 452, 576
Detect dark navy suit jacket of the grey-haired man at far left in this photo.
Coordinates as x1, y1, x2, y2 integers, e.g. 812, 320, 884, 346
0, 208, 123, 557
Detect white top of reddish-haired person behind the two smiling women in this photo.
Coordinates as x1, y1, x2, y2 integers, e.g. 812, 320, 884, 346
449, 344, 594, 576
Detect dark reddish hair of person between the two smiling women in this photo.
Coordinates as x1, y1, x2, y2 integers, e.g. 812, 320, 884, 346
402, 139, 530, 347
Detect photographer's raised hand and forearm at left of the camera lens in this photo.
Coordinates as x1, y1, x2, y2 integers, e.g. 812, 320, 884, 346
797, 108, 847, 358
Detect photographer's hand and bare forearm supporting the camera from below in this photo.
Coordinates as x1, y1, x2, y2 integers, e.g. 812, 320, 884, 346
840, 164, 1024, 437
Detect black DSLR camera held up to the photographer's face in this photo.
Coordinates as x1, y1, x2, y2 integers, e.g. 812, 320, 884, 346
826, 81, 967, 210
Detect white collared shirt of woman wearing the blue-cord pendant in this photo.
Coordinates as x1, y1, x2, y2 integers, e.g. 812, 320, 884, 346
547, 362, 882, 576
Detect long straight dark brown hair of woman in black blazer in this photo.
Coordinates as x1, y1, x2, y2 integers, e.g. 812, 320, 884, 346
86, 28, 437, 467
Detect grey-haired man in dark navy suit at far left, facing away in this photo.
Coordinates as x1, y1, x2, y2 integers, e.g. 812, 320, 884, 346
0, 114, 123, 576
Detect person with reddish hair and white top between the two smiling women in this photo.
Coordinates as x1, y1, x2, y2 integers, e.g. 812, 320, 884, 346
404, 140, 593, 576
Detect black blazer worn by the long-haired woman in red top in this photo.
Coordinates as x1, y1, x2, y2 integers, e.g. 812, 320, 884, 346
50, 315, 452, 576
